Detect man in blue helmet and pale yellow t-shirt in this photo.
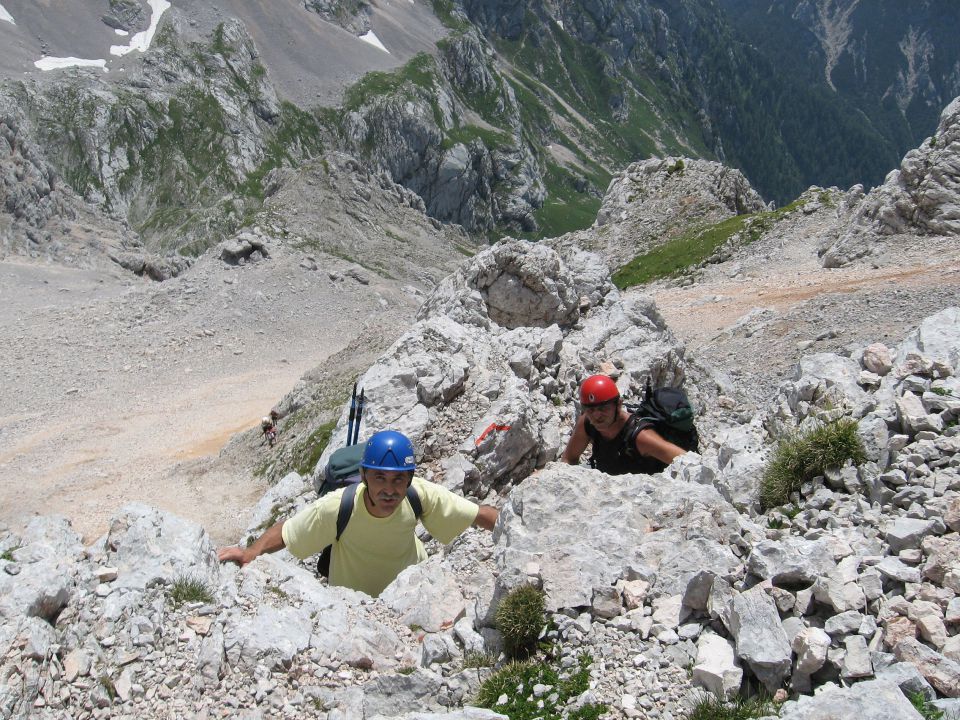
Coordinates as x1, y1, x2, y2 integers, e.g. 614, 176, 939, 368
218, 430, 497, 597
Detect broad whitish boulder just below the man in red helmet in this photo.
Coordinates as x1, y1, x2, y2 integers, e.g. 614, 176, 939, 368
499, 465, 740, 610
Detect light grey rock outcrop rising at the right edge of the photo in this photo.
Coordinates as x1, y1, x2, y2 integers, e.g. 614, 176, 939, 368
822, 98, 960, 267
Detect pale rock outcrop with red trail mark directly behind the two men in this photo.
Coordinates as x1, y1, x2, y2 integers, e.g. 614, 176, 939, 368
306, 241, 684, 497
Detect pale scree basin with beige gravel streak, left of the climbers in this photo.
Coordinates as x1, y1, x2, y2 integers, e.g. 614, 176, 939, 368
0, 261, 372, 542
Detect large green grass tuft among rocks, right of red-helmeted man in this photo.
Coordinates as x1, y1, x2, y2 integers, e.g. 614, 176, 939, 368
760, 418, 867, 509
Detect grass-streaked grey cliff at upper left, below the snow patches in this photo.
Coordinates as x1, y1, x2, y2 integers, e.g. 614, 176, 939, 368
0, 19, 292, 258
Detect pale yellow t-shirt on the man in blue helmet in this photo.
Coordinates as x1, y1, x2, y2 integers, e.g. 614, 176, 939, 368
283, 478, 480, 597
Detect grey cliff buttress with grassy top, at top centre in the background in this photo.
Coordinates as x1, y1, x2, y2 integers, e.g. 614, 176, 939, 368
343, 31, 546, 231
